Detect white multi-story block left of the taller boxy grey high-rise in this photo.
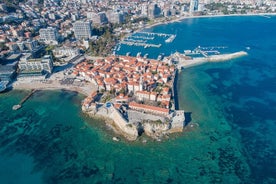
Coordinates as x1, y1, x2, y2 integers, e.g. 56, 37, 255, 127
39, 27, 58, 44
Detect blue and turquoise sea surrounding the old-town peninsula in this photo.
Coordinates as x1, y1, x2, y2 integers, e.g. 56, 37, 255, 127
0, 16, 276, 183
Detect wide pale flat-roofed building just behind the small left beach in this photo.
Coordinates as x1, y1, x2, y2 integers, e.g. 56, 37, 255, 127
18, 54, 53, 73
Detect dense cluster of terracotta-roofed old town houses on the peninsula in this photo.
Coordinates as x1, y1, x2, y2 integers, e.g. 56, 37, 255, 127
73, 56, 175, 113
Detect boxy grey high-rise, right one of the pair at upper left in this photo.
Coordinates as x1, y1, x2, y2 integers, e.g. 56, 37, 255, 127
73, 21, 92, 40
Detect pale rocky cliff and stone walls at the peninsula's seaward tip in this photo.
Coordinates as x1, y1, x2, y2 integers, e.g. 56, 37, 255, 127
82, 103, 185, 141
